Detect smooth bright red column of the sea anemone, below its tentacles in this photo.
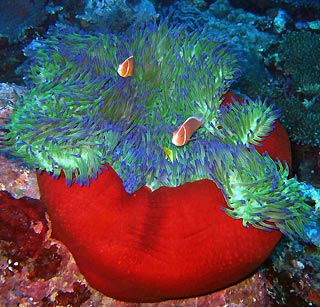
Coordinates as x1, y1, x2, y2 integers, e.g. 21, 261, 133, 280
38, 94, 291, 302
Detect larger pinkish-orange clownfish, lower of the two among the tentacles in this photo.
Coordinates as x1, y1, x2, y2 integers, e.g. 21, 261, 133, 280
172, 116, 203, 146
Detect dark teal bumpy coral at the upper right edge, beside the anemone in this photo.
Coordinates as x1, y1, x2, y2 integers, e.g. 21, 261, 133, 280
267, 31, 320, 147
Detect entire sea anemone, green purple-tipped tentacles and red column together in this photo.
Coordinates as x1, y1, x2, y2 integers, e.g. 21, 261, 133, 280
1, 23, 314, 301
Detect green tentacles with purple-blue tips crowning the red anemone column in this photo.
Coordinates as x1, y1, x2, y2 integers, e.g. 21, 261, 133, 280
4, 23, 318, 243
